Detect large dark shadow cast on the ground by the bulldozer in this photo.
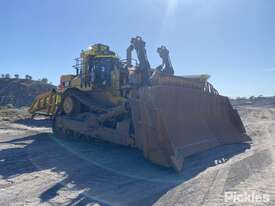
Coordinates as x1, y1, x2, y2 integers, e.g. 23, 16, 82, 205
0, 131, 250, 206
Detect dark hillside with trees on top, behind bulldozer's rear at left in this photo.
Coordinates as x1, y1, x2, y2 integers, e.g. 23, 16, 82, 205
0, 79, 55, 107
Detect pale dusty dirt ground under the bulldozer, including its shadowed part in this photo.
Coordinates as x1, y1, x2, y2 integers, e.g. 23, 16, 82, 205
0, 107, 275, 206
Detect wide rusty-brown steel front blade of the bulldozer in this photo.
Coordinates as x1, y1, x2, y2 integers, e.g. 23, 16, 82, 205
130, 85, 250, 172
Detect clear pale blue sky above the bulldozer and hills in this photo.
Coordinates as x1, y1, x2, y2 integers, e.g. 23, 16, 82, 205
0, 0, 275, 97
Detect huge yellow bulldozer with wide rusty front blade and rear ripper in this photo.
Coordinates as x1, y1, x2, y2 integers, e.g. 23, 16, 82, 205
30, 37, 250, 171
